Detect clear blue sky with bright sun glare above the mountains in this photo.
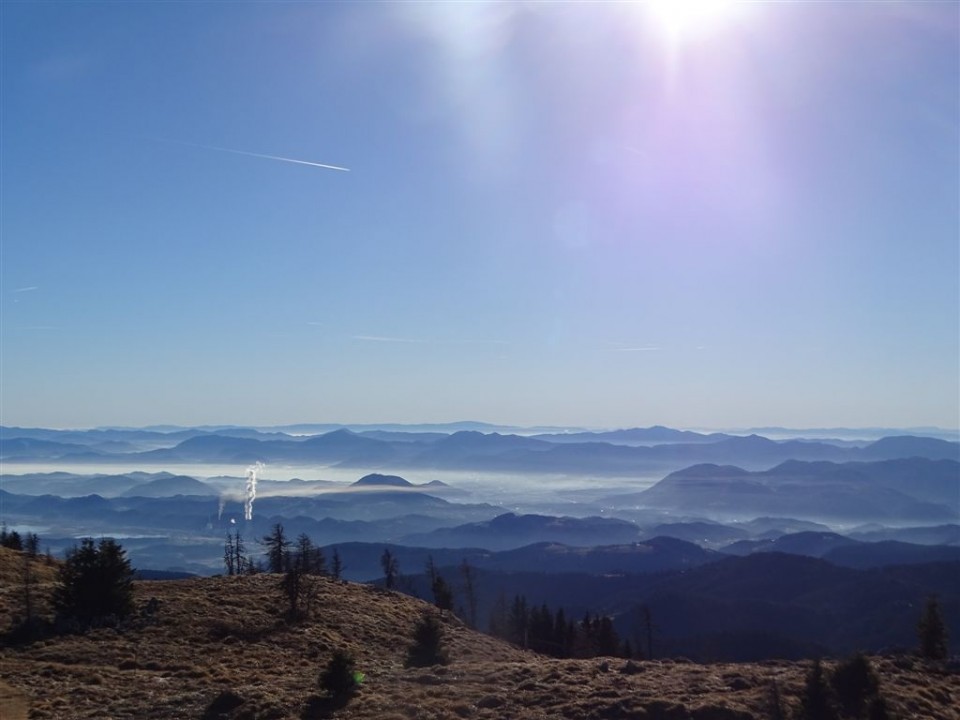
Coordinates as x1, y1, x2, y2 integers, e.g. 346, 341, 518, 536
0, 1, 960, 427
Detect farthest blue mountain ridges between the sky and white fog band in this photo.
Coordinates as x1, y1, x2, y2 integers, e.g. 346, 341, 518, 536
0, 427, 960, 475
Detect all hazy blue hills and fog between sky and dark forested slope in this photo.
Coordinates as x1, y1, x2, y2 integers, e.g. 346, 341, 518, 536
0, 427, 960, 580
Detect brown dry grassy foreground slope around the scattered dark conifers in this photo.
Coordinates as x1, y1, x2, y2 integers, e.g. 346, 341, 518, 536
0, 575, 960, 720
